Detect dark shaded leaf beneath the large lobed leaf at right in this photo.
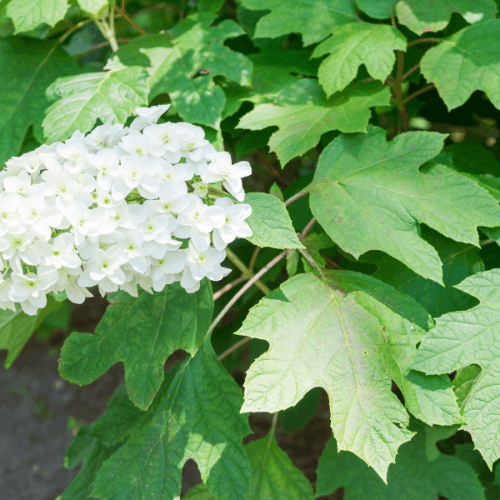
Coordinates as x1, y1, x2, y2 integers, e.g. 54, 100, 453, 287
362, 228, 484, 318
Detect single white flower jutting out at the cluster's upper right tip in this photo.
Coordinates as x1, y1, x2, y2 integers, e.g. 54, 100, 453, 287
201, 152, 252, 201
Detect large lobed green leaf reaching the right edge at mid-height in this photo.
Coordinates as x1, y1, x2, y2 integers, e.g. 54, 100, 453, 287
309, 127, 500, 284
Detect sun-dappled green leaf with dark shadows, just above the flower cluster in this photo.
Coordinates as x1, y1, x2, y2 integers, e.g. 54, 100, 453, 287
118, 14, 252, 129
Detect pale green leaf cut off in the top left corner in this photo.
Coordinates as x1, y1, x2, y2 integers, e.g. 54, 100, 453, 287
7, 0, 69, 33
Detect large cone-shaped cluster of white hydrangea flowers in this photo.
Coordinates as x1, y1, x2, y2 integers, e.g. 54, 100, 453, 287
0, 105, 252, 315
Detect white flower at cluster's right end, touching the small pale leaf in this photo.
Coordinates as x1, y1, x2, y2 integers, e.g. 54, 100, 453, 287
213, 198, 252, 250
